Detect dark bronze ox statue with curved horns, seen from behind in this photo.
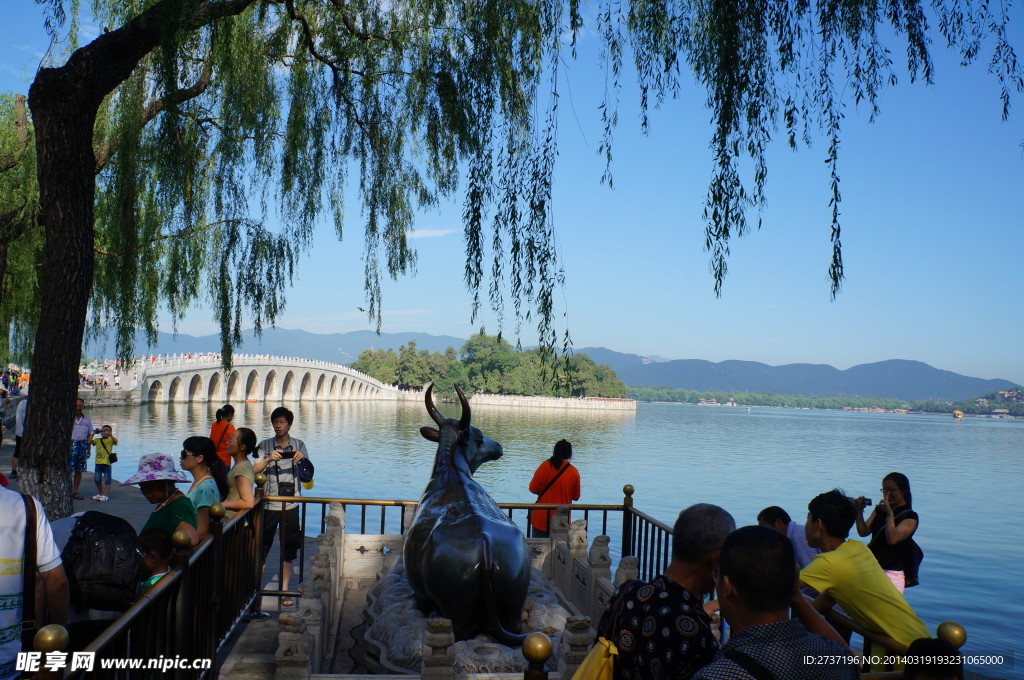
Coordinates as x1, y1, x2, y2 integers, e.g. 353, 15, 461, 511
403, 385, 530, 645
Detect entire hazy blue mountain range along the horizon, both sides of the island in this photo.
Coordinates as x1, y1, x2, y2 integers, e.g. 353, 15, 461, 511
85, 328, 1015, 401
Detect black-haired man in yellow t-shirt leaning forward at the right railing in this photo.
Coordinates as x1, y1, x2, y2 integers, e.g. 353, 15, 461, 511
800, 488, 932, 645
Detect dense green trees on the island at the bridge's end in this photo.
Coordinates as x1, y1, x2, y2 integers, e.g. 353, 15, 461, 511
352, 333, 626, 397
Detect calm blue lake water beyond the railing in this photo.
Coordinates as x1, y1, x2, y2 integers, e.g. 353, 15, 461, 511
91, 401, 1024, 678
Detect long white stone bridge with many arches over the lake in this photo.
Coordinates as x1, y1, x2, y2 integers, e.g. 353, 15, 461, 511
130, 354, 400, 403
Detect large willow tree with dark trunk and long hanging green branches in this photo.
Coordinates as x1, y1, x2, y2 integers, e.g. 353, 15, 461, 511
0, 0, 1021, 517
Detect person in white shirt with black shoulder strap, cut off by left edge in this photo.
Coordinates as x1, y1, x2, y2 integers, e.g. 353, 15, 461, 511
0, 486, 69, 680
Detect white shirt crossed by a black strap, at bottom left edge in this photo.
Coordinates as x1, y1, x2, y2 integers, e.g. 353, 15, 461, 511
0, 486, 60, 680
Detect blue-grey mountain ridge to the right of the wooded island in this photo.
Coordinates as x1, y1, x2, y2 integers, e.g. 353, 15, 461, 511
578, 347, 1015, 401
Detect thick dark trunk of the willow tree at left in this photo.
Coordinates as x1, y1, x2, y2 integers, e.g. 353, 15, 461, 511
18, 68, 98, 520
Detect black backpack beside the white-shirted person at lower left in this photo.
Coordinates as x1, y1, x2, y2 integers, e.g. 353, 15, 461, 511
60, 510, 145, 611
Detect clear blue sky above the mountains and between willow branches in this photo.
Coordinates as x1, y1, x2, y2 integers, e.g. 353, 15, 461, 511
0, 6, 1024, 382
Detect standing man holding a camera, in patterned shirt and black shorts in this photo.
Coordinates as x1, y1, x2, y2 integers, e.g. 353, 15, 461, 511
253, 407, 308, 606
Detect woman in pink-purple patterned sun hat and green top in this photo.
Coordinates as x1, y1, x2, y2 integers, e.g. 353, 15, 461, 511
122, 454, 199, 547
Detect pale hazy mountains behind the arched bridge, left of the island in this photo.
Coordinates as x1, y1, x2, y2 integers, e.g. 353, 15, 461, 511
84, 328, 466, 364
